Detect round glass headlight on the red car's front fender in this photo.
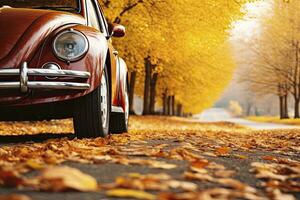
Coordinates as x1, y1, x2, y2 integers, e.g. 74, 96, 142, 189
53, 29, 89, 61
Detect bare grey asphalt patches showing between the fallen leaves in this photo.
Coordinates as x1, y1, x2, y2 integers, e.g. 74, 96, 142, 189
0, 138, 300, 200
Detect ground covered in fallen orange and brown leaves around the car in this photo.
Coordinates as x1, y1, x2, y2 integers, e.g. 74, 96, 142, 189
0, 117, 300, 200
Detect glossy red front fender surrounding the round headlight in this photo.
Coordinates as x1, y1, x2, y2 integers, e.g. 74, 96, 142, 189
24, 25, 108, 104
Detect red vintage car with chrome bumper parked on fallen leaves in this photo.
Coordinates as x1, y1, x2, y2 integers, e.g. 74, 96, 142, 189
0, 0, 129, 138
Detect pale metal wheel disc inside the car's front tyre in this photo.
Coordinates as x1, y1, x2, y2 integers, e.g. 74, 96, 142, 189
101, 73, 108, 128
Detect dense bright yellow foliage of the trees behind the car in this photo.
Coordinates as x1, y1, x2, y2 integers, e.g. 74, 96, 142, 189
100, 0, 253, 113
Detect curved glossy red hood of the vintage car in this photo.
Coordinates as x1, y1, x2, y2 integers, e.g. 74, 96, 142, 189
0, 7, 85, 68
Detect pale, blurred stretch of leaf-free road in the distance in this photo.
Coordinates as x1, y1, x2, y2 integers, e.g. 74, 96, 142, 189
196, 108, 298, 130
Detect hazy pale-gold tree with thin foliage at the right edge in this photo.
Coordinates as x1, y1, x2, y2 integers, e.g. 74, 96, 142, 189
239, 0, 300, 118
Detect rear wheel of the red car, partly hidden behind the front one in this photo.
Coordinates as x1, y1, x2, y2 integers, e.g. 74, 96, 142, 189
110, 83, 129, 134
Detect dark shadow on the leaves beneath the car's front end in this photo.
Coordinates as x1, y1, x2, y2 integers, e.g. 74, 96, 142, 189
0, 133, 75, 144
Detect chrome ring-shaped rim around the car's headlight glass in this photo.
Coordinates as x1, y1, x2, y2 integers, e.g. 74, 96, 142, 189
52, 29, 90, 62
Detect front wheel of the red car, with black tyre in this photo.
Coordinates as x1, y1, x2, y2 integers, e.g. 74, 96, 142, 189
73, 67, 110, 138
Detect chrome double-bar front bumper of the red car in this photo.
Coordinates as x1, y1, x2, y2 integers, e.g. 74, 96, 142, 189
0, 62, 91, 92
